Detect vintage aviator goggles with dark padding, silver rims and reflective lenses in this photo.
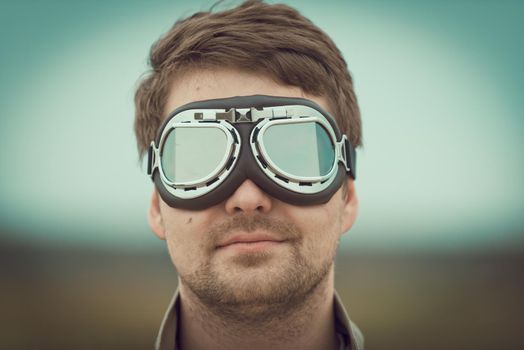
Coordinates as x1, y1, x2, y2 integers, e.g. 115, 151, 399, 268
147, 95, 356, 210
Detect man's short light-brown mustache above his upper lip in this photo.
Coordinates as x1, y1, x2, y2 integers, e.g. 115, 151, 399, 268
207, 214, 302, 244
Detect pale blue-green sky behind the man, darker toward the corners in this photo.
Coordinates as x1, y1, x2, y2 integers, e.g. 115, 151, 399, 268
0, 0, 524, 251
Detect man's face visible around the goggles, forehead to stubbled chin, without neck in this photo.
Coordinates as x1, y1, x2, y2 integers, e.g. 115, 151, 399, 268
149, 70, 358, 318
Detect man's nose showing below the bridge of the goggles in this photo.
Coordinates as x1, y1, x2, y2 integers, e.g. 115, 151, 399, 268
226, 179, 273, 214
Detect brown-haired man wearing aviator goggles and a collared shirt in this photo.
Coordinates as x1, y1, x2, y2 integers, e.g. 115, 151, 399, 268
135, 1, 363, 350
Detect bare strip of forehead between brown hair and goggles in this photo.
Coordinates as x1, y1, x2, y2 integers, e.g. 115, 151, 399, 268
164, 69, 331, 116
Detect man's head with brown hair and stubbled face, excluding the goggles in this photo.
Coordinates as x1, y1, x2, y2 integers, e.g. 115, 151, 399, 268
135, 1, 361, 319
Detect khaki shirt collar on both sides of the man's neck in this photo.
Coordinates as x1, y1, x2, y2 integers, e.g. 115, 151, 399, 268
155, 289, 364, 350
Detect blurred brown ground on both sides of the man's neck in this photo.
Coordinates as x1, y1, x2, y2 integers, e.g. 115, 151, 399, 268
0, 237, 524, 350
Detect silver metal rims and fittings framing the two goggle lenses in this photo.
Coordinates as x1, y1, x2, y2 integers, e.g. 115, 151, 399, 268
148, 105, 351, 199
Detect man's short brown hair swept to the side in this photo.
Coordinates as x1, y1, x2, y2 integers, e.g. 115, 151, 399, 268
135, 0, 362, 156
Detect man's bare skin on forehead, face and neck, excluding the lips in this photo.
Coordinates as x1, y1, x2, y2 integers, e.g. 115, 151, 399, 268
149, 69, 358, 350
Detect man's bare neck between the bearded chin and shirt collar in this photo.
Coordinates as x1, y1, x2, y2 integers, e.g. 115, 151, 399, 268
178, 268, 338, 350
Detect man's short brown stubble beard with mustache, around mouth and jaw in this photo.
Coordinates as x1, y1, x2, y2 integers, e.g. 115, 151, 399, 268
180, 215, 336, 327
